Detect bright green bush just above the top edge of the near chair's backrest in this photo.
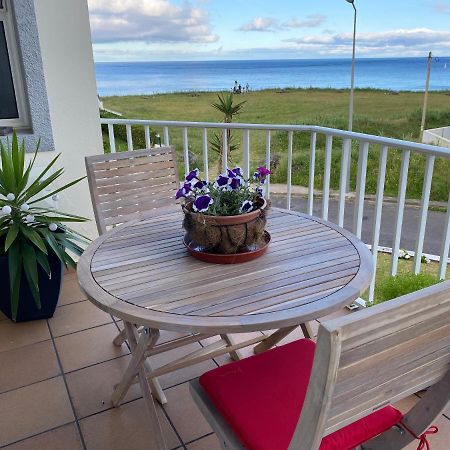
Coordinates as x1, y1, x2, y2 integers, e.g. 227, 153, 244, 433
375, 273, 439, 304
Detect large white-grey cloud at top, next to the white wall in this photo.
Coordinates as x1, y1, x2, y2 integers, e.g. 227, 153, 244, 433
88, 0, 219, 43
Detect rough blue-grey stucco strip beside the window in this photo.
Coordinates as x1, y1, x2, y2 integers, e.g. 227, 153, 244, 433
2, 0, 54, 151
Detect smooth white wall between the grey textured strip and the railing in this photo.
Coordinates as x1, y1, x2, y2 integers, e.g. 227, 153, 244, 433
31, 0, 103, 237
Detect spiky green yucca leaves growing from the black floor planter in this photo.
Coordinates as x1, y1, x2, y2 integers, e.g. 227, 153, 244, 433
0, 132, 88, 320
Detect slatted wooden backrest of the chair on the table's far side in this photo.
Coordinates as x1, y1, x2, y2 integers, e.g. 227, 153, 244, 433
86, 147, 179, 234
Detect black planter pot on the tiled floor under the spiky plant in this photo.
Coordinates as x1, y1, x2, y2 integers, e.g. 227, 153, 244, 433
0, 252, 64, 322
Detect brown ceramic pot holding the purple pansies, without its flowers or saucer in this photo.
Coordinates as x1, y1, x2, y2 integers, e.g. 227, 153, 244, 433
183, 198, 267, 255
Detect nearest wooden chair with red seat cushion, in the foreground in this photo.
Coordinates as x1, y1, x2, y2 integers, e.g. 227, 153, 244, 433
191, 282, 450, 450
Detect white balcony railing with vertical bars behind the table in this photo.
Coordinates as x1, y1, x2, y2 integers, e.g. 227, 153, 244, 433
101, 119, 450, 301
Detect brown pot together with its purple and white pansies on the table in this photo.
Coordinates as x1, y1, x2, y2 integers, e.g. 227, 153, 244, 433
176, 167, 271, 255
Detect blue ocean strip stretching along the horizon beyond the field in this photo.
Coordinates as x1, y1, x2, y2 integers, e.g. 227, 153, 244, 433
95, 57, 450, 96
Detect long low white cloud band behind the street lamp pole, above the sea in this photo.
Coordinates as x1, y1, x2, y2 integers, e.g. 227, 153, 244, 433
285, 28, 450, 55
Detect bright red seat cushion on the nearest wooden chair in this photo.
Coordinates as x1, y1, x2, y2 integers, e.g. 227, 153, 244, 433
200, 339, 402, 450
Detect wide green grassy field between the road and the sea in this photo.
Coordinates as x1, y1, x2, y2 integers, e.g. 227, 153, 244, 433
103, 89, 450, 201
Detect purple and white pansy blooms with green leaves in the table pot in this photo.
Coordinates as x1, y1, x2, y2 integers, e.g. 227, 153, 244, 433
176, 166, 272, 216
